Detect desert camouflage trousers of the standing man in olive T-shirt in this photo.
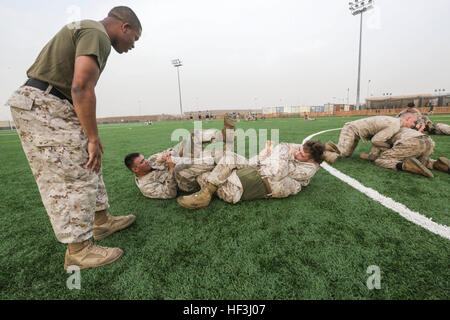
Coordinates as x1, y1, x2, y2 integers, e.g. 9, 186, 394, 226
8, 87, 109, 243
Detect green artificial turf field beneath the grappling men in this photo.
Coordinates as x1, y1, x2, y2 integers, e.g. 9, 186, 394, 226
0, 115, 450, 300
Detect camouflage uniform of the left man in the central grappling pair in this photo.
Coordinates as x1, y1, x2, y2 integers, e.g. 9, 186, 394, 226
135, 129, 222, 199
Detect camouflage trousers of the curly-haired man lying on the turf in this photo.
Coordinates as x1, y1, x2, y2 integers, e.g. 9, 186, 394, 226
197, 152, 248, 203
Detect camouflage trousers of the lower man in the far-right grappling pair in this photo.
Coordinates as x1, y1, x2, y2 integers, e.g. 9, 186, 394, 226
375, 136, 435, 170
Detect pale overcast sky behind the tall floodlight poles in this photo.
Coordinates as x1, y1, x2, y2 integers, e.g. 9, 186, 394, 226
0, 0, 450, 120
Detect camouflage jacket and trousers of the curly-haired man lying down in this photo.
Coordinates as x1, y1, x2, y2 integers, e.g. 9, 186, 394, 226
198, 143, 320, 203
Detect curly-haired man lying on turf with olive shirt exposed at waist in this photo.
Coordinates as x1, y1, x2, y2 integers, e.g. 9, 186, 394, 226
178, 141, 325, 209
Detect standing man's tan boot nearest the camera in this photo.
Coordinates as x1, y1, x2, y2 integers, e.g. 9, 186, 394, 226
64, 240, 123, 270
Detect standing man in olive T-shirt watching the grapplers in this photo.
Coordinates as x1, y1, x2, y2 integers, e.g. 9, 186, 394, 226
6, 6, 142, 269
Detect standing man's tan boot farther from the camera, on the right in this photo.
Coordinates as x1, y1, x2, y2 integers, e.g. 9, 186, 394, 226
93, 210, 136, 240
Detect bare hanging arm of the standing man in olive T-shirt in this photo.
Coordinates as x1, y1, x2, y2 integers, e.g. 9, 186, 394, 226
72, 56, 104, 172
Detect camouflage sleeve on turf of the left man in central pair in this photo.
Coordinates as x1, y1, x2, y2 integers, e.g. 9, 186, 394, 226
139, 171, 177, 199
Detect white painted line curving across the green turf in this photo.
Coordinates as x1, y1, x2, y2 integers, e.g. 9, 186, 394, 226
303, 128, 450, 240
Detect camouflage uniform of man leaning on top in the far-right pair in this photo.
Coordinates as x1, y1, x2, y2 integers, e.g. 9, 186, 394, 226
338, 116, 402, 157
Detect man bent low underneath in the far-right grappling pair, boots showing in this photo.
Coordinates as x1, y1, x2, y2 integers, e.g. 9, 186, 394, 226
360, 128, 450, 178
